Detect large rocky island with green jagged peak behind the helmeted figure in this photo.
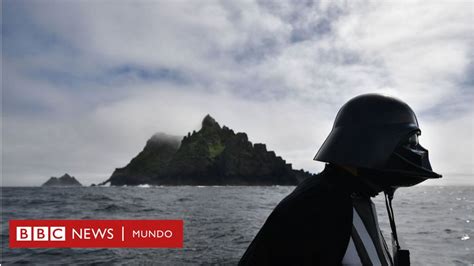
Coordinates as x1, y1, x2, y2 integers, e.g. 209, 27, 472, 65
101, 115, 312, 186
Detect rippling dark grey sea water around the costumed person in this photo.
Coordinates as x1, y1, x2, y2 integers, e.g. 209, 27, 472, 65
1, 186, 474, 265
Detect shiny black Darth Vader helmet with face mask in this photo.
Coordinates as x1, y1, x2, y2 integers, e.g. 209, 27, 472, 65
314, 94, 441, 187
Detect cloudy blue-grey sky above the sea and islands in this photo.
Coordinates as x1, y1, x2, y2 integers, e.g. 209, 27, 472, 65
1, 0, 474, 186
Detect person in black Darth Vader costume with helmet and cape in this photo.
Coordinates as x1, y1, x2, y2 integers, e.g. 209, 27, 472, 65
239, 94, 441, 265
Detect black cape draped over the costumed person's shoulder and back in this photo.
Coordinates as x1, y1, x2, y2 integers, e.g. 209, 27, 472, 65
239, 165, 356, 265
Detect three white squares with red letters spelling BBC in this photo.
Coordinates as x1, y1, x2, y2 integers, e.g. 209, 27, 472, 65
16, 226, 66, 241
